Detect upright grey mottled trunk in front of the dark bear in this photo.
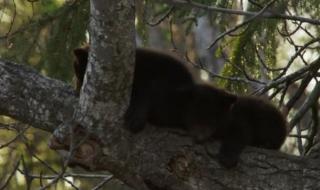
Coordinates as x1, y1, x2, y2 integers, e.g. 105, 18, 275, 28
74, 0, 135, 138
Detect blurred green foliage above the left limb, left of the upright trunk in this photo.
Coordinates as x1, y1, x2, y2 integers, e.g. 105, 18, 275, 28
0, 0, 89, 81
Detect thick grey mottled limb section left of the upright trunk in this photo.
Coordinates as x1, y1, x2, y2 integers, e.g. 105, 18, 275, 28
0, 59, 77, 131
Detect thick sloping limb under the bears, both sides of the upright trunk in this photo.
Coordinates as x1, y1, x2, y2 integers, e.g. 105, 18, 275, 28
0, 47, 320, 190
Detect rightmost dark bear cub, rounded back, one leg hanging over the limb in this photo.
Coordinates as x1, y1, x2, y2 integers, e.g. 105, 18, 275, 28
215, 96, 287, 167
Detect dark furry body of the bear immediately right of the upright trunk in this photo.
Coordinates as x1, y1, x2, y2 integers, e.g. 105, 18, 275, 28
126, 48, 195, 132
